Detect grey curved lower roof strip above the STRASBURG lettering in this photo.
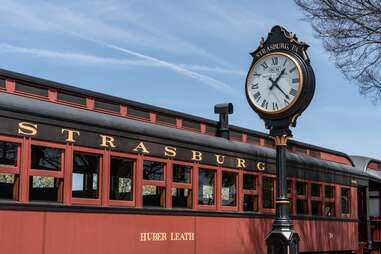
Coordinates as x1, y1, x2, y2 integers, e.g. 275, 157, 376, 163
0, 93, 368, 181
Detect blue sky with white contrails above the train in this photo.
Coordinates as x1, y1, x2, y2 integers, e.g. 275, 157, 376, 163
0, 0, 381, 159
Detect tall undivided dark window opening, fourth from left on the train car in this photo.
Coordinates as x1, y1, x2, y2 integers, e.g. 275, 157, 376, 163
110, 157, 135, 200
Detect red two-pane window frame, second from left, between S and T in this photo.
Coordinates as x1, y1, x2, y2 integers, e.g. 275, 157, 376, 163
27, 140, 66, 203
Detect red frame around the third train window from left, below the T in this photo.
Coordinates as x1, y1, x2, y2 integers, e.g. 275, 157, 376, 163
69, 146, 105, 205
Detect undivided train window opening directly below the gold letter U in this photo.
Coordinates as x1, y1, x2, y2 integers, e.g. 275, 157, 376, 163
221, 171, 237, 206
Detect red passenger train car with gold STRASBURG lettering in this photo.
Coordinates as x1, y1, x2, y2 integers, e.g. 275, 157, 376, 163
0, 70, 381, 254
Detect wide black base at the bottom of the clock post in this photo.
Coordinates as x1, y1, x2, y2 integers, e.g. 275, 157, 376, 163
266, 229, 300, 254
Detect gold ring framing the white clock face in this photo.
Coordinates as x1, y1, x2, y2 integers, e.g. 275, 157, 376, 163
246, 51, 304, 115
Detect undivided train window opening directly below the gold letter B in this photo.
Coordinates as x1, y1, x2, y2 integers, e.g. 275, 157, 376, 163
198, 169, 216, 205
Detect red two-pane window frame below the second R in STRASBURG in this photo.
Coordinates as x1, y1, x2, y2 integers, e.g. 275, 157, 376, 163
239, 171, 260, 213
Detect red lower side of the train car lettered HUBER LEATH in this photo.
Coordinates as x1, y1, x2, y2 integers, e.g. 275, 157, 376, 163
0, 211, 358, 254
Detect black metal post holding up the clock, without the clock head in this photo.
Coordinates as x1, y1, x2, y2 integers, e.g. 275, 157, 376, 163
266, 135, 299, 254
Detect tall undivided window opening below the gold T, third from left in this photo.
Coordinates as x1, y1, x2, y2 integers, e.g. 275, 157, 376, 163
72, 152, 100, 198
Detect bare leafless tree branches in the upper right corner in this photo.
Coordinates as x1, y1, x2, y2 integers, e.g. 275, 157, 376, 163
294, 0, 381, 102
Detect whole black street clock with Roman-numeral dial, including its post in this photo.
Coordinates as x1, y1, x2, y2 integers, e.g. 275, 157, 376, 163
245, 26, 315, 254
